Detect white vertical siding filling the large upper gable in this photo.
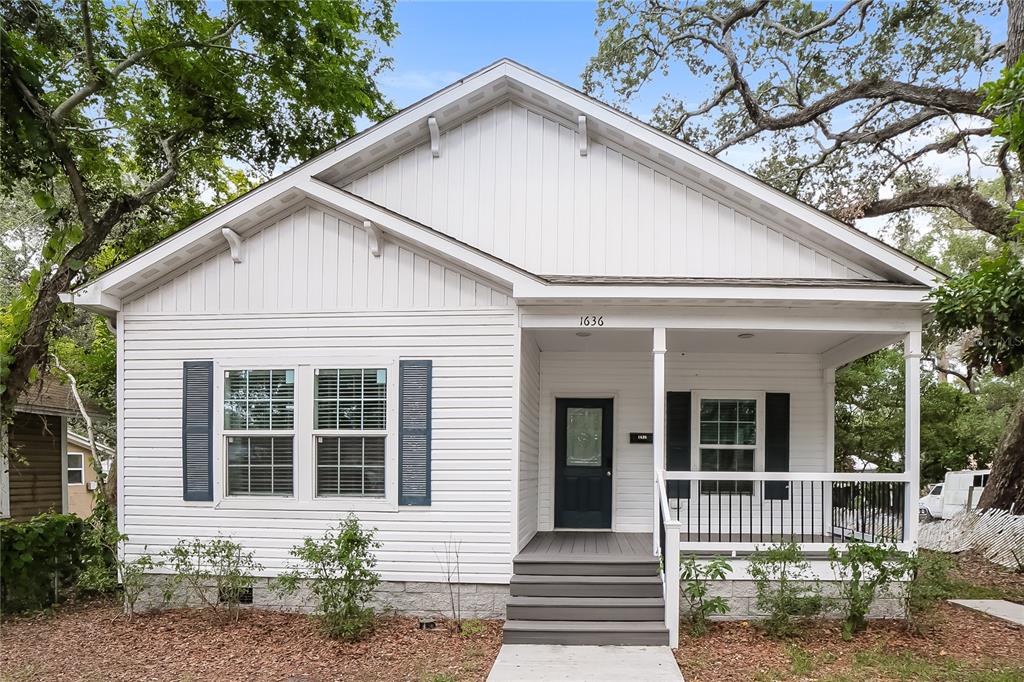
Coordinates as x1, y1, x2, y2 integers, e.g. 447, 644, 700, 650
344, 101, 881, 280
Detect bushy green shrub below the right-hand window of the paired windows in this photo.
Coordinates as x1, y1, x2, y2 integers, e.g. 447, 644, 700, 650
274, 515, 380, 639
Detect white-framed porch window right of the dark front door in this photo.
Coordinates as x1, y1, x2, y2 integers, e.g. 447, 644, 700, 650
700, 398, 758, 495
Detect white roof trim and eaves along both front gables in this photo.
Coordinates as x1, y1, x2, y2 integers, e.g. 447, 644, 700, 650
66, 59, 943, 311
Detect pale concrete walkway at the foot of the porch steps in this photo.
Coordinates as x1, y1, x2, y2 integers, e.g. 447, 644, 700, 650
487, 644, 683, 682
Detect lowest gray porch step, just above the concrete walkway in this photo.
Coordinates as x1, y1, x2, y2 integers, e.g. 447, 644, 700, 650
502, 621, 669, 646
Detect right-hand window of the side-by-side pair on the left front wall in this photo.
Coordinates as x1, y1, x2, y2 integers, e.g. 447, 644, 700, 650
313, 368, 388, 498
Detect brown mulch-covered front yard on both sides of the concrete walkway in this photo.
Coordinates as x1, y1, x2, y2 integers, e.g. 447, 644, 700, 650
0, 556, 1024, 682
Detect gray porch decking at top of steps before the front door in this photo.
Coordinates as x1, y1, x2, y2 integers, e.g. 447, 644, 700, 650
516, 530, 654, 563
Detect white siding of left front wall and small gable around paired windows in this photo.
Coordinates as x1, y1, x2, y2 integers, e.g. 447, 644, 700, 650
119, 201, 518, 583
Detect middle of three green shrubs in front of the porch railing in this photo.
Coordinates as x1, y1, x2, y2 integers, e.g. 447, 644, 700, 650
750, 543, 822, 637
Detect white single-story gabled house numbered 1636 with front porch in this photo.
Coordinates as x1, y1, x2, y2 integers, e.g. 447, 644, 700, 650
66, 60, 941, 643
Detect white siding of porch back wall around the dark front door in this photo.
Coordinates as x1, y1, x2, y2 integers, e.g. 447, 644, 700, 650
539, 352, 830, 532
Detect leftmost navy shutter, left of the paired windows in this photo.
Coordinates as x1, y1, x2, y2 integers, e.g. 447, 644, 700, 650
181, 360, 213, 502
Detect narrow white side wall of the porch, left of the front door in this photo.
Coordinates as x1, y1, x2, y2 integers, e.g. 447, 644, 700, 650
518, 336, 541, 549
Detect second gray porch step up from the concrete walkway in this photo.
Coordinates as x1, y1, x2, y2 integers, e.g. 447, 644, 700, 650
508, 597, 665, 622
